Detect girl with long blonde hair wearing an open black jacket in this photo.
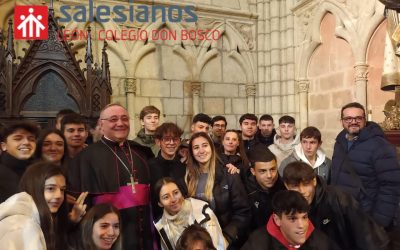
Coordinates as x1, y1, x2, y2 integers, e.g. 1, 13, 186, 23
185, 132, 251, 249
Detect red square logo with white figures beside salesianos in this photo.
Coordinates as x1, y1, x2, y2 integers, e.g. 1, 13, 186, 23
14, 5, 49, 40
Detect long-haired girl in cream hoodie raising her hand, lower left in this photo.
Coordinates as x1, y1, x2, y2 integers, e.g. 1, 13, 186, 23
0, 162, 87, 250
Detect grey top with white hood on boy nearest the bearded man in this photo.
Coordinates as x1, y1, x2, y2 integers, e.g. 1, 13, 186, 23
278, 143, 332, 181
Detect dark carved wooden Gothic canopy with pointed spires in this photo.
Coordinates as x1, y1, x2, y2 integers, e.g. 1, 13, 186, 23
0, 3, 112, 125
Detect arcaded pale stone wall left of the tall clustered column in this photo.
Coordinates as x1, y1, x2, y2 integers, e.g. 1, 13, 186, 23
0, 0, 257, 137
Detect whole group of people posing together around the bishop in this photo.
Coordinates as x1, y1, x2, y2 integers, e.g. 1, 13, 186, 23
0, 100, 400, 250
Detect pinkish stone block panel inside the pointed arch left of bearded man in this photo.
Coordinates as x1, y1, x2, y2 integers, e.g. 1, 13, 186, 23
308, 13, 354, 156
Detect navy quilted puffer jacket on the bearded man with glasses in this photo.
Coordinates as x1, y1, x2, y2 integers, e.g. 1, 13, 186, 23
331, 122, 400, 227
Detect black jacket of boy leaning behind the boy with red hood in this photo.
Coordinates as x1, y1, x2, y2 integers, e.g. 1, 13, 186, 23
308, 176, 388, 250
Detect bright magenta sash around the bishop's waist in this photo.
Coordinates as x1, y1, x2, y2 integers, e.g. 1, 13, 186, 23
94, 184, 150, 209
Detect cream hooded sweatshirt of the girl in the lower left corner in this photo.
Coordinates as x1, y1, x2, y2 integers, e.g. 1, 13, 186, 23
0, 192, 46, 250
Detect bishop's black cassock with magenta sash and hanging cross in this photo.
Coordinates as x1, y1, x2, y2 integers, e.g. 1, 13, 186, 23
68, 137, 156, 250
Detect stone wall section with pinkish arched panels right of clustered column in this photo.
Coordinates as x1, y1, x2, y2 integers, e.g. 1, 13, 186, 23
293, 0, 390, 155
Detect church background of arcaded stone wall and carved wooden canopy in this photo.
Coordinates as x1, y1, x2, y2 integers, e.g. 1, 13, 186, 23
0, 0, 400, 155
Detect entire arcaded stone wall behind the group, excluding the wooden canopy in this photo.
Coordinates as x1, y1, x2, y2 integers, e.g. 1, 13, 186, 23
0, 0, 392, 147
